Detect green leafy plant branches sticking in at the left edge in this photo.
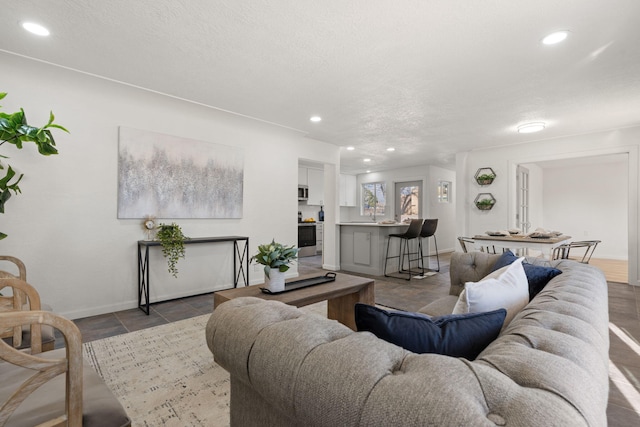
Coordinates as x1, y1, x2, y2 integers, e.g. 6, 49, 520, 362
0, 92, 69, 240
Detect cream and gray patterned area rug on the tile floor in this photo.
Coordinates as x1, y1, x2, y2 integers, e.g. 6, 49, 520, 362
83, 302, 327, 427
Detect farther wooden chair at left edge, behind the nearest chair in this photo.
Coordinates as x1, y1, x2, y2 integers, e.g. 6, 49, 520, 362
0, 255, 56, 351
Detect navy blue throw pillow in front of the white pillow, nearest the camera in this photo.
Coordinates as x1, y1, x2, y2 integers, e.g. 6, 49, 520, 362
355, 303, 507, 360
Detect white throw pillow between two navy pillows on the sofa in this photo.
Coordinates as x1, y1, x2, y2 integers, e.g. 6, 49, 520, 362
453, 257, 529, 328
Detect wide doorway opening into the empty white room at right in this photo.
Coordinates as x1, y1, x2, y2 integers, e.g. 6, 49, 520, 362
515, 153, 633, 283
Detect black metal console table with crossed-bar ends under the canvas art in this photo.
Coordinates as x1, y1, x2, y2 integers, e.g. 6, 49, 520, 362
138, 236, 249, 315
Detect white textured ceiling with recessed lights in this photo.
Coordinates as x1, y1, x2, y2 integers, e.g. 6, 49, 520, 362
0, 0, 640, 173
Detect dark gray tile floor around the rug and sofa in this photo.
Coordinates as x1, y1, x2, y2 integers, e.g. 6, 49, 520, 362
66, 255, 640, 427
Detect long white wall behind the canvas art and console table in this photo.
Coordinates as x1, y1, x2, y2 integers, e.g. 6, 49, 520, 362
0, 53, 340, 318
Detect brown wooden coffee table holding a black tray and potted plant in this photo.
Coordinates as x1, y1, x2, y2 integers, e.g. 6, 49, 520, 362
213, 273, 375, 331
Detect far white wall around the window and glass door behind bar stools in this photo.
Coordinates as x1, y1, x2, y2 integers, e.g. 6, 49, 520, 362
340, 165, 457, 252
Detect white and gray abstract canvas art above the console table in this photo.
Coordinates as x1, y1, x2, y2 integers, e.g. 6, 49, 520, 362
118, 127, 244, 219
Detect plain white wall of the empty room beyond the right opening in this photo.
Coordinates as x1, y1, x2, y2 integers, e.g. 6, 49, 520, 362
543, 162, 628, 260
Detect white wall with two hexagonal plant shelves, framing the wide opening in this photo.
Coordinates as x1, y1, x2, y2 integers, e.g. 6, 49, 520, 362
456, 127, 640, 284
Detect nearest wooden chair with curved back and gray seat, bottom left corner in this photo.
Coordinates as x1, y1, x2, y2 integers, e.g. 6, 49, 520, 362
0, 278, 131, 427
